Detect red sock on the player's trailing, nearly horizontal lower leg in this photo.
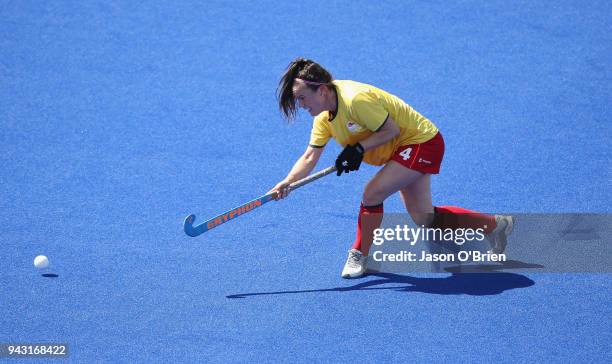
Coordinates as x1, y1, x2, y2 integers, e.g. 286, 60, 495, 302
432, 206, 497, 234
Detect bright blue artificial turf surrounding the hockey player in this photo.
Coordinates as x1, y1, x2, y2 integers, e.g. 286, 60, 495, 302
0, 0, 612, 363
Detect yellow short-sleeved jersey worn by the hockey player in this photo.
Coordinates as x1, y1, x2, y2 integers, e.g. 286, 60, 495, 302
309, 80, 438, 166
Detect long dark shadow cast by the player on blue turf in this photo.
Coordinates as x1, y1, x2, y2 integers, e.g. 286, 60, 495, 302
227, 273, 535, 298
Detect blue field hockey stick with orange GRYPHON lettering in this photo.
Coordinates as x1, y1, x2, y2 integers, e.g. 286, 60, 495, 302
183, 166, 336, 237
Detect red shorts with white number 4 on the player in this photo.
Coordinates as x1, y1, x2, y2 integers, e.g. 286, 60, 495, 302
391, 132, 444, 174
